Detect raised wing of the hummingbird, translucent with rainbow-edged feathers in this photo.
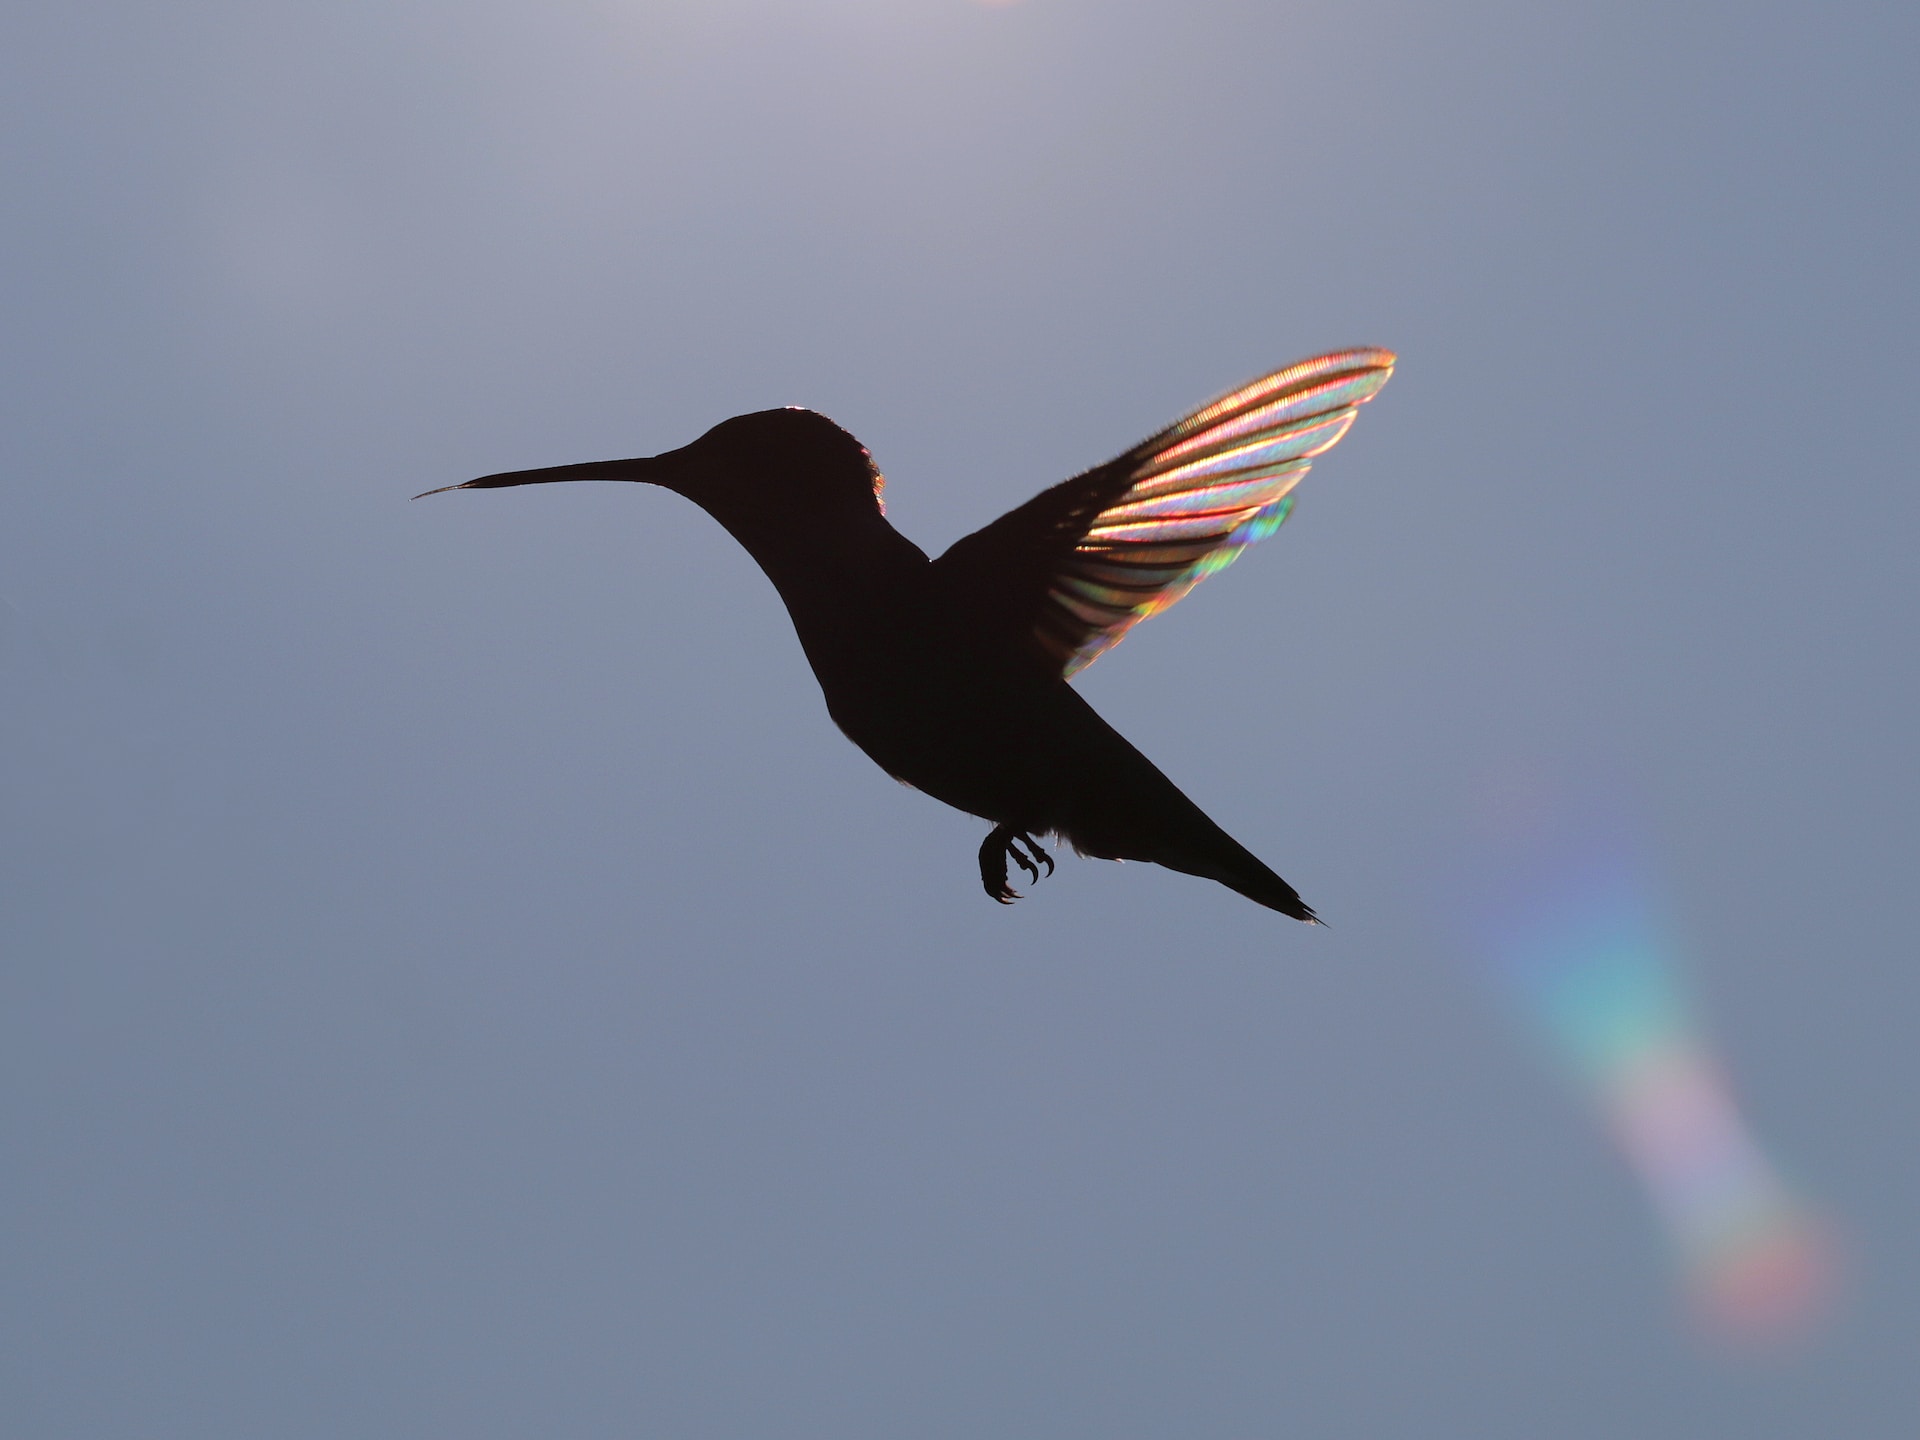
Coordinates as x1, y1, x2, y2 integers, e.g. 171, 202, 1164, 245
935, 348, 1396, 676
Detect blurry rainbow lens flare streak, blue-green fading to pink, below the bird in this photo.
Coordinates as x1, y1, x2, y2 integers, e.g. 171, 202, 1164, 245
1490, 821, 1836, 1342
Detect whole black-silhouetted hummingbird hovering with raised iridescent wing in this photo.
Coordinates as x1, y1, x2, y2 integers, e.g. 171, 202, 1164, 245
426, 349, 1394, 924
